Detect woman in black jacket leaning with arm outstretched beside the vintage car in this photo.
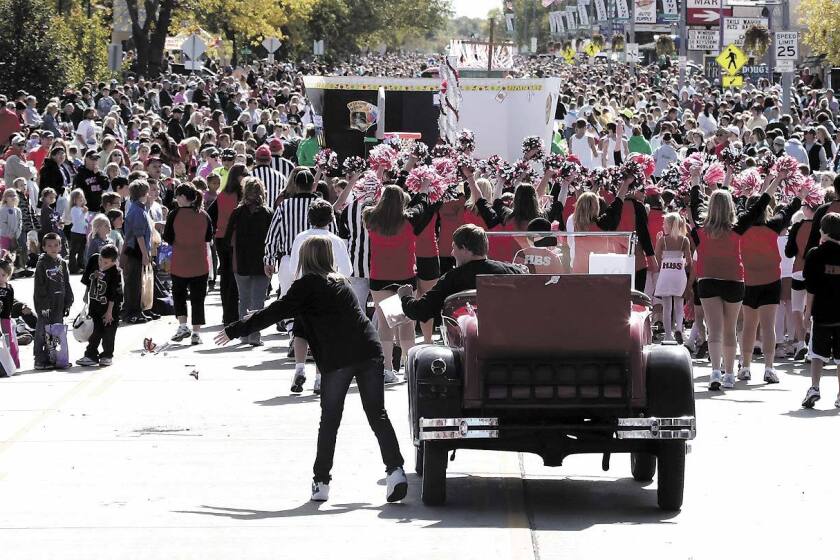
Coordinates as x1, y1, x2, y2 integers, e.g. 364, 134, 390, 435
215, 235, 408, 502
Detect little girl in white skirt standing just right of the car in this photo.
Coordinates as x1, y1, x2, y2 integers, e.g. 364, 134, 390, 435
654, 212, 691, 344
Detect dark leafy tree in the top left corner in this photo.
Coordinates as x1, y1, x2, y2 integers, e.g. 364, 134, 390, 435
0, 0, 79, 100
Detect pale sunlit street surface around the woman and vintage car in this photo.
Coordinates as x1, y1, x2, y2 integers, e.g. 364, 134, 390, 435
0, 274, 840, 560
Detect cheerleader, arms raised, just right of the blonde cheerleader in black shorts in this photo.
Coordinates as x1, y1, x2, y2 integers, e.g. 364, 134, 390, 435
738, 180, 807, 383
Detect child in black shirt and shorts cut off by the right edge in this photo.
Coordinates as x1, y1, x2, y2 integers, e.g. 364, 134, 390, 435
802, 212, 840, 408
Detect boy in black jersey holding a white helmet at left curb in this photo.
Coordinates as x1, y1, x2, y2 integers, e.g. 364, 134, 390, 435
76, 245, 123, 366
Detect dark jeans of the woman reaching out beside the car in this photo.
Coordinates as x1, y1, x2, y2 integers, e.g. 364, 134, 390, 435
312, 358, 403, 483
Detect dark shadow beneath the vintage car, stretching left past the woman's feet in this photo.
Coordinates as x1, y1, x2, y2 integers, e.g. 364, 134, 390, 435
175, 474, 679, 531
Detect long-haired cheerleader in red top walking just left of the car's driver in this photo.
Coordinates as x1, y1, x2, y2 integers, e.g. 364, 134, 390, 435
363, 185, 437, 383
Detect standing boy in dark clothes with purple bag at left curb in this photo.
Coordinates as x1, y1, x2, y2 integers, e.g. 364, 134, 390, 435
34, 233, 73, 369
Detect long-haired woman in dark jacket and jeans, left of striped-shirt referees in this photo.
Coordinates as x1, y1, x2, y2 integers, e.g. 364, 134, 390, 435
224, 177, 271, 346
